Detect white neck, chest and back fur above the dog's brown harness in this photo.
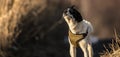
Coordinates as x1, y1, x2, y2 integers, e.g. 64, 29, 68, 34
68, 20, 93, 34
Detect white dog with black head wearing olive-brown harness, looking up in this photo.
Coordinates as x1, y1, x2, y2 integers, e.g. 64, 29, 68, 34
63, 6, 93, 57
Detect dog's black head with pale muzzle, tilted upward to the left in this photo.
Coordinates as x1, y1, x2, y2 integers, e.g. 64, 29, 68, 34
63, 6, 83, 23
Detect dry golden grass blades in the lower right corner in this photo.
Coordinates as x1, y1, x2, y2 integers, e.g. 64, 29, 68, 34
101, 29, 120, 57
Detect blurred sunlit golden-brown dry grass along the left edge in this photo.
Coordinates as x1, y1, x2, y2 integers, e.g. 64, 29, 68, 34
0, 0, 46, 57
